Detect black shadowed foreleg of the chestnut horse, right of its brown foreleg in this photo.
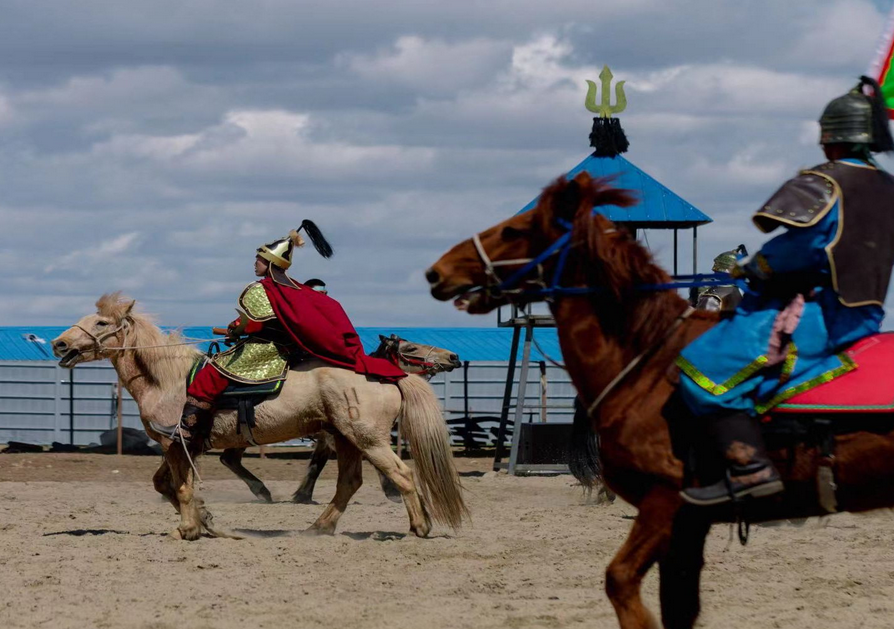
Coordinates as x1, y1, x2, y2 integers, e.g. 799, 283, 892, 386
658, 506, 711, 629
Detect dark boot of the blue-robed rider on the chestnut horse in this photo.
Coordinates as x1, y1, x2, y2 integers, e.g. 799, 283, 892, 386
680, 412, 783, 506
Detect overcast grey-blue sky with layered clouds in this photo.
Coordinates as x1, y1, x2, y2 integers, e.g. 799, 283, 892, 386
0, 0, 890, 326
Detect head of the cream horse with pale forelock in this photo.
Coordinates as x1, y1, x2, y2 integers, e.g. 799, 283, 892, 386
52, 293, 136, 369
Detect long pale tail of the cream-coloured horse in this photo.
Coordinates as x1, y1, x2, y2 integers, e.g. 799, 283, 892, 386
397, 375, 469, 529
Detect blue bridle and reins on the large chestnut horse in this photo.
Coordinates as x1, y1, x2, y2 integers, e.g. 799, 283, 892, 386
472, 210, 745, 299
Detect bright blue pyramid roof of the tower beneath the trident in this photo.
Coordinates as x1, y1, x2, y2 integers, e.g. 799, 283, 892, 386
519, 155, 712, 229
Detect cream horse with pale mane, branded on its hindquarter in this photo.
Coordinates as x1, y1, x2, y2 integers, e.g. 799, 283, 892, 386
53, 294, 468, 540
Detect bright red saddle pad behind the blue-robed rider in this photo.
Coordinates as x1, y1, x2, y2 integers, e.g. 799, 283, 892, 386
771, 332, 894, 413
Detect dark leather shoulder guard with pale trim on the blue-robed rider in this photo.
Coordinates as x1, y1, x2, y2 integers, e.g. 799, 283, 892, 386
752, 164, 841, 233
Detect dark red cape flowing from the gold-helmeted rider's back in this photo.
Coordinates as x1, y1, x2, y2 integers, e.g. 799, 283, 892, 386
261, 277, 407, 382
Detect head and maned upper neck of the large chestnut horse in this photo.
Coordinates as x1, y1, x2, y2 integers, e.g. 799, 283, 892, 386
426, 172, 652, 313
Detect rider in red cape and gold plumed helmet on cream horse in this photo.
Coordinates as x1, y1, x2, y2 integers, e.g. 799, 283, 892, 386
151, 221, 407, 449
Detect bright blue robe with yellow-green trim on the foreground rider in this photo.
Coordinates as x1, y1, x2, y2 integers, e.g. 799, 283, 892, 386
677, 168, 884, 416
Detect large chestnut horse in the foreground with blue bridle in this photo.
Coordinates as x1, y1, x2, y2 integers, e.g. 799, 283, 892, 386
426, 173, 894, 629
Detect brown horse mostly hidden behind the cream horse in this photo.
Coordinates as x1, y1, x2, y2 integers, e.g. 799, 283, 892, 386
220, 334, 462, 504
